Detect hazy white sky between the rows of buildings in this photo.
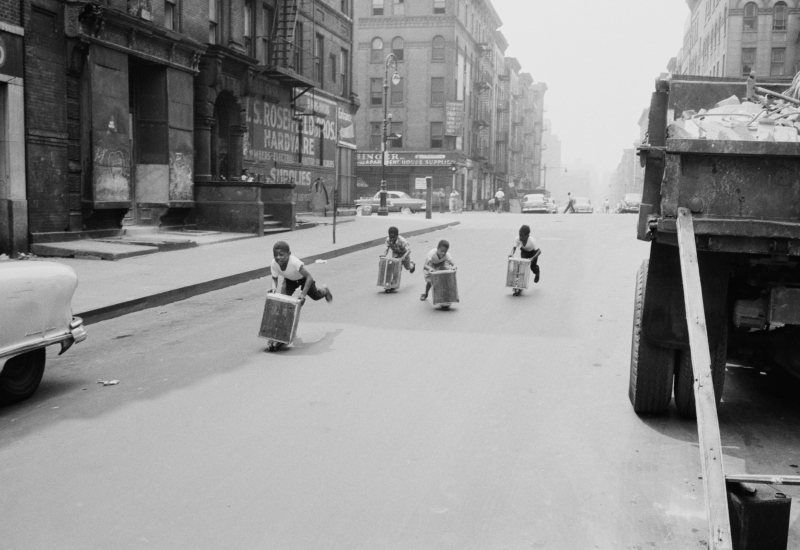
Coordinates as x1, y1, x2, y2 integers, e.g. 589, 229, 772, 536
491, 0, 689, 171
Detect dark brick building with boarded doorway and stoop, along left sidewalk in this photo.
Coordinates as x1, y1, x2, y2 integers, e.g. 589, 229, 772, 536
19, 0, 358, 251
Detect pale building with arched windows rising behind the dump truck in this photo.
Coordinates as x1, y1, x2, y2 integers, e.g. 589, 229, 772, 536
672, 0, 800, 80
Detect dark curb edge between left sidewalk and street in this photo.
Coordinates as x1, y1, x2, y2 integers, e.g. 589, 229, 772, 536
75, 222, 461, 325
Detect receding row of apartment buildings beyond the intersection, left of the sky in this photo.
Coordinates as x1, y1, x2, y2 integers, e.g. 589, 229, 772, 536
354, 0, 547, 208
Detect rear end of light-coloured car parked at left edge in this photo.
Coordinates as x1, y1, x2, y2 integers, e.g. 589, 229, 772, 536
0, 260, 86, 405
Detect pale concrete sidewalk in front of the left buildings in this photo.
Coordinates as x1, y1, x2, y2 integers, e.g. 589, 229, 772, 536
42, 213, 460, 324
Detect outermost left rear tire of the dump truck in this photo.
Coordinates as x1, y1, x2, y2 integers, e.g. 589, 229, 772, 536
628, 260, 675, 414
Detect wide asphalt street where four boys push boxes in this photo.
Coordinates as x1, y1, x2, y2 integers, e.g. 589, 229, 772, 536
0, 212, 800, 550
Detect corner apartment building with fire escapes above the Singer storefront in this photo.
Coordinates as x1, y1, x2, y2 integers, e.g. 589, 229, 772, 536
354, 0, 502, 207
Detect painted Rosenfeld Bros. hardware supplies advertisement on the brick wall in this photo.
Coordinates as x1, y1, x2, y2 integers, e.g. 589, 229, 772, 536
243, 94, 355, 193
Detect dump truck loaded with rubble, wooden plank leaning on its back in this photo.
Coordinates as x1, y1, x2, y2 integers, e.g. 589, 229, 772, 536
628, 76, 800, 548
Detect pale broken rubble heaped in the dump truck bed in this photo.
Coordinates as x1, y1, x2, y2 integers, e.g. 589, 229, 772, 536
667, 91, 800, 143
